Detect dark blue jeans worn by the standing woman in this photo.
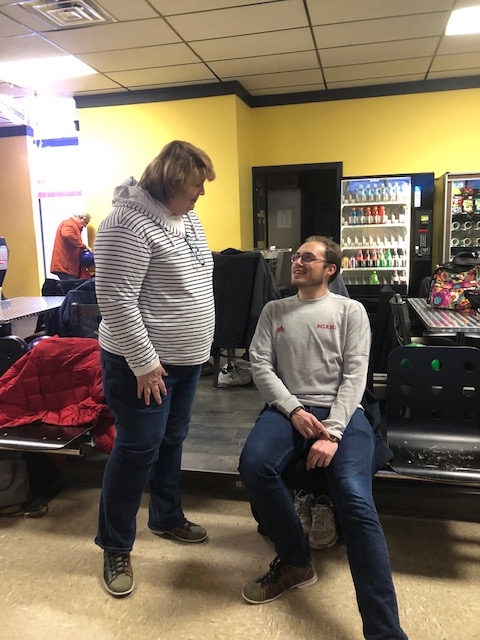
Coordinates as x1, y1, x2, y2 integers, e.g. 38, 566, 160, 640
95, 349, 201, 553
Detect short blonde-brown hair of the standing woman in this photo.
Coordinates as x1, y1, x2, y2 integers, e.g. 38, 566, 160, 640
139, 140, 216, 204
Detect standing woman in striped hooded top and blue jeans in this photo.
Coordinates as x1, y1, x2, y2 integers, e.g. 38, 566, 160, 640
95, 140, 215, 596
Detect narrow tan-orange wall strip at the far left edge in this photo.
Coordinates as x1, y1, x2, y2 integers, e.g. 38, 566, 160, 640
0, 136, 43, 298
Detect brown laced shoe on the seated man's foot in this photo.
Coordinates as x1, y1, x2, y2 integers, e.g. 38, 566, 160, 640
242, 556, 317, 604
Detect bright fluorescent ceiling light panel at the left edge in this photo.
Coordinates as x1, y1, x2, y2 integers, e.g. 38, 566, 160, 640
0, 56, 97, 90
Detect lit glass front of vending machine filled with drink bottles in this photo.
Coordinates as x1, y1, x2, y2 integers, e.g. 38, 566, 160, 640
340, 176, 412, 285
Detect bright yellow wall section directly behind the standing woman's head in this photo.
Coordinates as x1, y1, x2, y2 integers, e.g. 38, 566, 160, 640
80, 96, 246, 250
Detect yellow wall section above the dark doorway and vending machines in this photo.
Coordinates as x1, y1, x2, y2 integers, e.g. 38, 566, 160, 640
252, 89, 480, 176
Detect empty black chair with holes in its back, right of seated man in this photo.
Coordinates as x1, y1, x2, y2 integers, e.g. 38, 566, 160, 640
387, 346, 480, 484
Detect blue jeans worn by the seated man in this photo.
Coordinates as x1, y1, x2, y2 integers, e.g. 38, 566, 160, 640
239, 407, 406, 640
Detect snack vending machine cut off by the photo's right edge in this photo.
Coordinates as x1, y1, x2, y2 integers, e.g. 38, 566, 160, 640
436, 173, 480, 263
